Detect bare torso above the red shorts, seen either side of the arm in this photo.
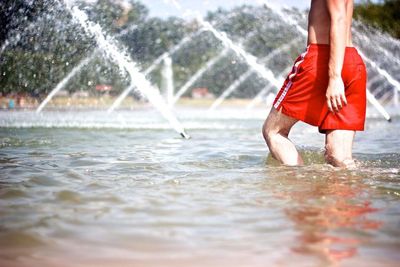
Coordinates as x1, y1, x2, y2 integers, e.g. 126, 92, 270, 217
308, 0, 353, 46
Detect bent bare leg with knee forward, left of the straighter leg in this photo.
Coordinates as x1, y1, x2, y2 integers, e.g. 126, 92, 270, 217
263, 108, 303, 165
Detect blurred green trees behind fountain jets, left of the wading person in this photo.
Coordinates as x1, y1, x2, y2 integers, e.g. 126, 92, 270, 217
0, 0, 299, 97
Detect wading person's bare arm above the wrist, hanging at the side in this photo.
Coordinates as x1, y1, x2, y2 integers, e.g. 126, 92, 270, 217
327, 0, 346, 78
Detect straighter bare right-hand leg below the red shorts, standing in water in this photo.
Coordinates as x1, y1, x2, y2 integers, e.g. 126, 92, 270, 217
325, 130, 356, 168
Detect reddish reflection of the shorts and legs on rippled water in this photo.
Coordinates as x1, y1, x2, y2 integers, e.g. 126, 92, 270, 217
268, 169, 383, 264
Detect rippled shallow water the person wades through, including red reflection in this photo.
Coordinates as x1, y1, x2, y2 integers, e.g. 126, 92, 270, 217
0, 109, 400, 266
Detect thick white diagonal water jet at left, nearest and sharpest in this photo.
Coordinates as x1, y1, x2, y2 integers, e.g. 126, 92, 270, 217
64, 1, 189, 138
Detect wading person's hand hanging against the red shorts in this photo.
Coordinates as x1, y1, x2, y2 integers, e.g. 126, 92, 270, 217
326, 77, 347, 112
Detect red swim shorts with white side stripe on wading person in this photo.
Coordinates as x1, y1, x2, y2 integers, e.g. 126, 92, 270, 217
273, 44, 367, 133
